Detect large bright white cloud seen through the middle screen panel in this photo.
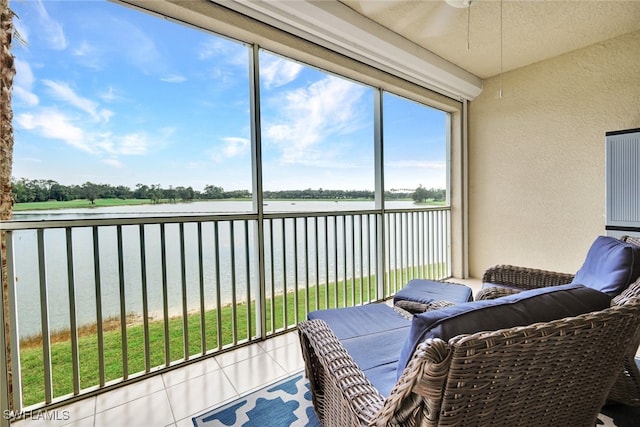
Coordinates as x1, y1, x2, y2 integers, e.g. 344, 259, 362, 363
265, 76, 364, 163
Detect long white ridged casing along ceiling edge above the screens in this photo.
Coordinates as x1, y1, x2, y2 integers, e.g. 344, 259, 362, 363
209, 0, 482, 101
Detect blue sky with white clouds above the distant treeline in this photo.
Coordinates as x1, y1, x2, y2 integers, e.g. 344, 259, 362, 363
10, 0, 446, 191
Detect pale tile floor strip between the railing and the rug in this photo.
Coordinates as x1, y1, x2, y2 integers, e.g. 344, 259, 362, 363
11, 332, 304, 427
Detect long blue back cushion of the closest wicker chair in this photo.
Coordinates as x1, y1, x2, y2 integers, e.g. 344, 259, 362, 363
396, 284, 611, 378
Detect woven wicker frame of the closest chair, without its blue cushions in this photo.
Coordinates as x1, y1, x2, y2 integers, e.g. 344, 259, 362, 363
299, 296, 640, 427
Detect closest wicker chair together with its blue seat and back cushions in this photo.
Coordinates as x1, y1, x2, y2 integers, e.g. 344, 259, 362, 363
299, 236, 640, 426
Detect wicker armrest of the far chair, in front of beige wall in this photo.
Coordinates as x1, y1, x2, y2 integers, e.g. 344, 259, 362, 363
482, 265, 574, 289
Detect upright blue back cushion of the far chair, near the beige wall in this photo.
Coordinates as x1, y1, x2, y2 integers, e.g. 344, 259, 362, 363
571, 236, 640, 297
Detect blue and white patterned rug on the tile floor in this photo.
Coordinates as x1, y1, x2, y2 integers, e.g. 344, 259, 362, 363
193, 372, 320, 427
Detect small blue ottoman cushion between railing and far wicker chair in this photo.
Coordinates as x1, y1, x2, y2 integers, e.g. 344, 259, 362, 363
393, 279, 473, 304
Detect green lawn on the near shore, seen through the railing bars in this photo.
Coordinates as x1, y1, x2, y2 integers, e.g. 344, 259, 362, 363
20, 277, 392, 406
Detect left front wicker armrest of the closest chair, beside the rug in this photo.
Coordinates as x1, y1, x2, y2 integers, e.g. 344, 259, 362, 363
298, 319, 384, 425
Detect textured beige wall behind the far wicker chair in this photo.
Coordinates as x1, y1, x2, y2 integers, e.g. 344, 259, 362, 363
469, 32, 640, 277
